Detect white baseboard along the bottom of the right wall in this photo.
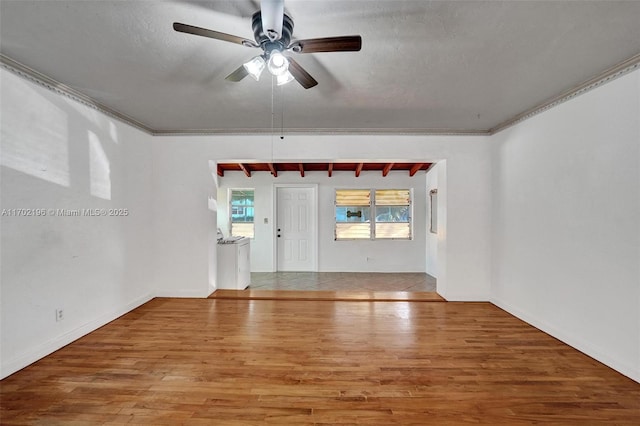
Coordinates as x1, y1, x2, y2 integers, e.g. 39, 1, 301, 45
490, 298, 640, 383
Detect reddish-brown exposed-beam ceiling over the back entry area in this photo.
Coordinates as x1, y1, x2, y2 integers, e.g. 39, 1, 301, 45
218, 162, 432, 177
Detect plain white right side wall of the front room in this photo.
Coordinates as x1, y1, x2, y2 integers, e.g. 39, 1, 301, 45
491, 71, 640, 381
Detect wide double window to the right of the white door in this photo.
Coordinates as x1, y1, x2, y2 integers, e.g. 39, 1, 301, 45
335, 189, 411, 240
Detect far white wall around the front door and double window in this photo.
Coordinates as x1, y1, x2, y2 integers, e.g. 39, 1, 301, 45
218, 171, 427, 272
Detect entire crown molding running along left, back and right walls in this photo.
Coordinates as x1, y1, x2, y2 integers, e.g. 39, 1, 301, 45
0, 53, 640, 136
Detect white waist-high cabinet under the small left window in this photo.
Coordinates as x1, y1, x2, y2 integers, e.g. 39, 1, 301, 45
217, 238, 251, 290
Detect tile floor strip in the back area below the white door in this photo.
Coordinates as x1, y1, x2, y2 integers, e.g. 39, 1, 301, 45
249, 272, 436, 292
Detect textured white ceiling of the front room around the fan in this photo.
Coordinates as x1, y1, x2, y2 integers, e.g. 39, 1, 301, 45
0, 0, 640, 132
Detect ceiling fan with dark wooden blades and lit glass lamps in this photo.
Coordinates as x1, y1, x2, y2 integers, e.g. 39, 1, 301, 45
173, 0, 362, 89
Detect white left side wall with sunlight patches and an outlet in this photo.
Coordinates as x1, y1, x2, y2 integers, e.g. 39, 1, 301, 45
0, 70, 152, 377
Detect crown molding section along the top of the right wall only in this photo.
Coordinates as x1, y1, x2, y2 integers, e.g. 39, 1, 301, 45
489, 53, 640, 135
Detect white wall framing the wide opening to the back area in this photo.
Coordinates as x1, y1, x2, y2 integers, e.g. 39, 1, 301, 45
153, 135, 491, 300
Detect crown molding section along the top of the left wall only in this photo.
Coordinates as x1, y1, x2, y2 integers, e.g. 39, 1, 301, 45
0, 53, 153, 134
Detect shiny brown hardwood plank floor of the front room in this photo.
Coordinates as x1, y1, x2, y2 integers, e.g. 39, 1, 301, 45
0, 298, 640, 425
